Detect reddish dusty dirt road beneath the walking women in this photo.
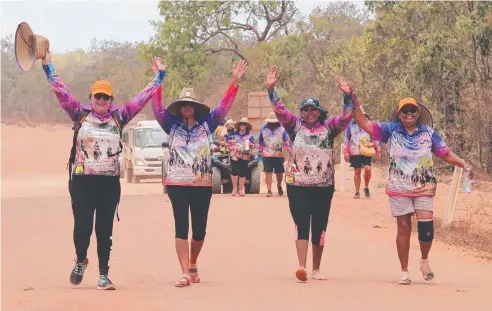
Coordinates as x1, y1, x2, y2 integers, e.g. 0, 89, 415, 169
1, 126, 492, 311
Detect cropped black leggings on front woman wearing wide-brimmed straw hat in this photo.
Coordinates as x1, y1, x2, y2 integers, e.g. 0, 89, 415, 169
167, 186, 212, 241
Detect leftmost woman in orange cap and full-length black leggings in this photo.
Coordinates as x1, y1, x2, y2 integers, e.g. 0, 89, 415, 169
42, 51, 166, 290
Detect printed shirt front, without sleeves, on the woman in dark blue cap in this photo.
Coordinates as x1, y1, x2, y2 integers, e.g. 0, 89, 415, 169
286, 125, 334, 187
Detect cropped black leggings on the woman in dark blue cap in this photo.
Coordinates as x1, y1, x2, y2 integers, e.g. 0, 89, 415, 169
287, 185, 335, 246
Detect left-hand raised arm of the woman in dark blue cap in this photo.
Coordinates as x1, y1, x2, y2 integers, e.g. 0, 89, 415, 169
265, 66, 299, 134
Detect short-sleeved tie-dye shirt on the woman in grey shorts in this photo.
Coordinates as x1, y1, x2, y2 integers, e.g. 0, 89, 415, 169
372, 122, 449, 197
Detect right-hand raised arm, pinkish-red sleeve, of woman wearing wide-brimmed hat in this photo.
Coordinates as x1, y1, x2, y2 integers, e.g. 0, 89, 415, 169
207, 60, 248, 132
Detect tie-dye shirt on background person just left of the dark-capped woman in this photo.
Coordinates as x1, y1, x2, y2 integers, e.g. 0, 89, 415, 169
258, 124, 290, 158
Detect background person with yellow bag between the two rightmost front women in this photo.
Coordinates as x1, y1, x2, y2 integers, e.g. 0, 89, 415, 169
344, 108, 381, 199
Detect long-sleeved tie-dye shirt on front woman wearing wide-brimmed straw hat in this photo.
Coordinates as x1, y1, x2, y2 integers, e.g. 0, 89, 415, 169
152, 85, 239, 187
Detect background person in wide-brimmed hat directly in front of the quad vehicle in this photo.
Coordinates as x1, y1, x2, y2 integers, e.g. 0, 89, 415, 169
226, 117, 255, 196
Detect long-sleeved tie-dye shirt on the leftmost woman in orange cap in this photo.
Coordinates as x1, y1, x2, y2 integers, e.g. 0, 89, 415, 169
43, 63, 166, 176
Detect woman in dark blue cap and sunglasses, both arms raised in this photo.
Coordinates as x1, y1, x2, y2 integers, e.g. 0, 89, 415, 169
265, 66, 354, 281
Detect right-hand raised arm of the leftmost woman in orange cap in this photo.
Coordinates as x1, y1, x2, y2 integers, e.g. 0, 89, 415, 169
120, 57, 167, 124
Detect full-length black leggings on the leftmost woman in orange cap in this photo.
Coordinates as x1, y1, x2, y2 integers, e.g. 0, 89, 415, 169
70, 175, 121, 274
